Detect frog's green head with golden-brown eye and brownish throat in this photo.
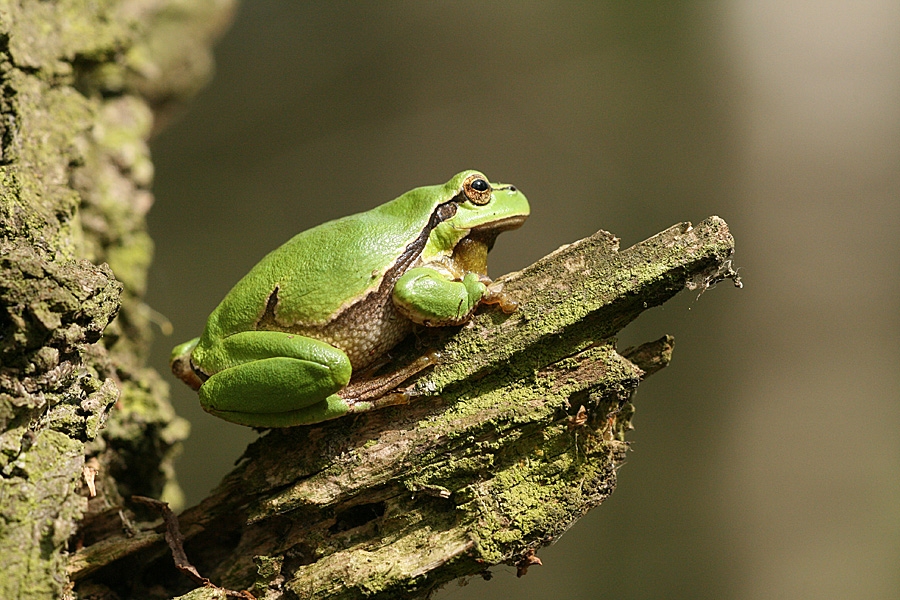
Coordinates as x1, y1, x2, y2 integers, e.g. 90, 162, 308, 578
423, 171, 531, 272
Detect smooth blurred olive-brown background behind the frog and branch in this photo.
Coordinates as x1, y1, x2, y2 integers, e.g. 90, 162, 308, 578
149, 0, 900, 600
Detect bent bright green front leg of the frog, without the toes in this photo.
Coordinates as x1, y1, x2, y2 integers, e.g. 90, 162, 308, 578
393, 267, 487, 327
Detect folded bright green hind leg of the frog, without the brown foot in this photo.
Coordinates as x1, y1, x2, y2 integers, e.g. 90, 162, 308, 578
195, 331, 352, 427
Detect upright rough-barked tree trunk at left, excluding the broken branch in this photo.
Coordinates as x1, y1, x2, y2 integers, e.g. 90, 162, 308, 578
0, 0, 236, 598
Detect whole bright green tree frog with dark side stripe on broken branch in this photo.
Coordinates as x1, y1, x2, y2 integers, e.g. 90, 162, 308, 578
170, 170, 530, 428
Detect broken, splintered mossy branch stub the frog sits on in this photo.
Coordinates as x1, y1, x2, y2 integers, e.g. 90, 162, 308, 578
70, 217, 739, 599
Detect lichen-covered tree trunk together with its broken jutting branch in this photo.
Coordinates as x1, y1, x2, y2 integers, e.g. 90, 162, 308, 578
0, 0, 735, 599
